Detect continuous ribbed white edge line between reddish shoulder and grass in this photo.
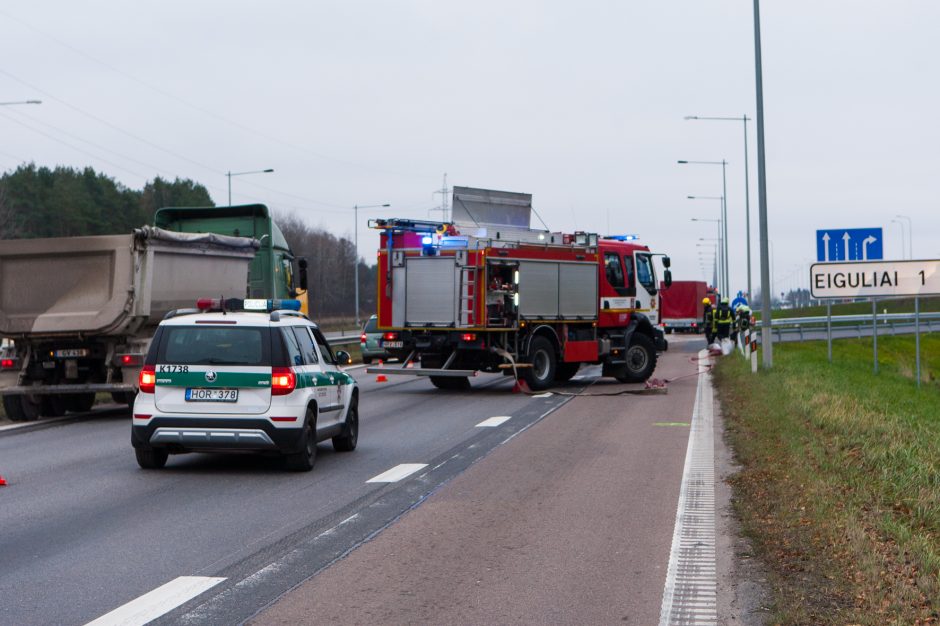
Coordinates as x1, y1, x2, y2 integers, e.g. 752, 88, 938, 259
659, 350, 718, 626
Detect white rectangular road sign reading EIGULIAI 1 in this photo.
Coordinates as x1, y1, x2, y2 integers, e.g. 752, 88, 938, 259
809, 260, 940, 298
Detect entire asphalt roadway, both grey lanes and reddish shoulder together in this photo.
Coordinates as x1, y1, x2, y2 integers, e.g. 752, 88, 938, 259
0, 338, 720, 625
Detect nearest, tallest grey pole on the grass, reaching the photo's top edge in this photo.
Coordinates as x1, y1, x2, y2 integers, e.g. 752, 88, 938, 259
754, 0, 774, 369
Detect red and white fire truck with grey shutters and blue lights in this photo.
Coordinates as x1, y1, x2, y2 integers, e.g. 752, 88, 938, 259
366, 187, 672, 390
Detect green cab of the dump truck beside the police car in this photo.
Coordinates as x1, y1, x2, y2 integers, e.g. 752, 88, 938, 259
153, 204, 309, 314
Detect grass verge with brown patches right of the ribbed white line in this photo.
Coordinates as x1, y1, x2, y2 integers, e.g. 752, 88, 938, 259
715, 336, 940, 625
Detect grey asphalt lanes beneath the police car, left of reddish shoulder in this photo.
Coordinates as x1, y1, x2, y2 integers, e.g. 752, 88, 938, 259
0, 370, 578, 625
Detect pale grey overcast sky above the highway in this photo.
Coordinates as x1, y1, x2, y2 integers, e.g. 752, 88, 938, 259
0, 0, 940, 293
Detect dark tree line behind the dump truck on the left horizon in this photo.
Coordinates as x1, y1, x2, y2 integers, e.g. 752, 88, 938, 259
0, 163, 376, 318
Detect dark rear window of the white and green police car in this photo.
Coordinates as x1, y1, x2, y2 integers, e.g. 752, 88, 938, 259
158, 326, 270, 365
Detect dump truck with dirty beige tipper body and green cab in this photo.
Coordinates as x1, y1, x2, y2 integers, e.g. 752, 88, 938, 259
0, 205, 306, 420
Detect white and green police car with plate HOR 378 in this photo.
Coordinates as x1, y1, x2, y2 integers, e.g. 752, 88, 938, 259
131, 299, 359, 471
